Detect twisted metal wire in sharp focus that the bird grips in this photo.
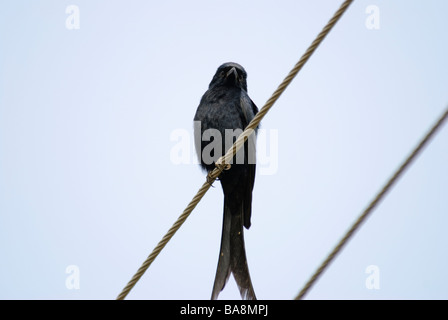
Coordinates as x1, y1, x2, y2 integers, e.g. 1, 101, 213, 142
117, 0, 353, 300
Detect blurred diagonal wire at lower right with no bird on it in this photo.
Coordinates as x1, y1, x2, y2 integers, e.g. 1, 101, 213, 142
295, 107, 448, 300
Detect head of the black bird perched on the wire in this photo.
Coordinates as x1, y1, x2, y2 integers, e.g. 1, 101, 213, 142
209, 62, 247, 92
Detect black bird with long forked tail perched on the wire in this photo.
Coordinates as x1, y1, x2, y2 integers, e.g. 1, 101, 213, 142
194, 62, 258, 300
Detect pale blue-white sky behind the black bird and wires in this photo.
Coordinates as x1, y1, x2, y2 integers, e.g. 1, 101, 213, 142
0, 0, 448, 299
